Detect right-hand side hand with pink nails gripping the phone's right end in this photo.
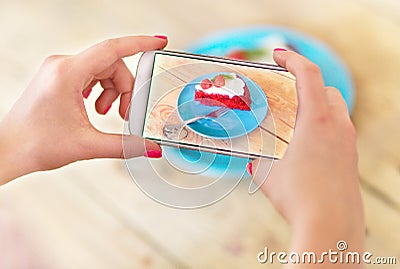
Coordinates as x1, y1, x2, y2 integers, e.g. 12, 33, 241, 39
247, 49, 365, 268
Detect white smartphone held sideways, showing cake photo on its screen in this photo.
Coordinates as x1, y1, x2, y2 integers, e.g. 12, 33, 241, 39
129, 50, 297, 159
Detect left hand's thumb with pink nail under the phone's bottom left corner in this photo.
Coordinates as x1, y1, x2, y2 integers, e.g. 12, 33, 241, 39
83, 133, 162, 159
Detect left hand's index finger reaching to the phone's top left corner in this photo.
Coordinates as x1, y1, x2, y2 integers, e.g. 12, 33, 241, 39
74, 36, 168, 76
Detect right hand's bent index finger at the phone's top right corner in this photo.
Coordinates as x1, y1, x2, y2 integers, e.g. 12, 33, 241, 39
274, 50, 327, 116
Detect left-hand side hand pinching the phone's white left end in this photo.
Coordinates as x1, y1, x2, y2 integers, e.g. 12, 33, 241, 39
0, 36, 168, 185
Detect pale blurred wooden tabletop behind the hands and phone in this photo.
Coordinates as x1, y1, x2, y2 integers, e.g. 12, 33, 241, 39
0, 0, 400, 268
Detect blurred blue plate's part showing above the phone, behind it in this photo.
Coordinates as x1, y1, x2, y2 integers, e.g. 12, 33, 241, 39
188, 26, 354, 112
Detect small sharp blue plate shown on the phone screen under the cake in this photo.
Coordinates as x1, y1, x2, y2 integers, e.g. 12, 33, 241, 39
177, 72, 268, 139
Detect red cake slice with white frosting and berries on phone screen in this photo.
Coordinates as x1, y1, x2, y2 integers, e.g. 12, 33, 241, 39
194, 73, 251, 110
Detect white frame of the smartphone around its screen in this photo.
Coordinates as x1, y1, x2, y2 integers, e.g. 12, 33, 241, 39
129, 50, 288, 159
